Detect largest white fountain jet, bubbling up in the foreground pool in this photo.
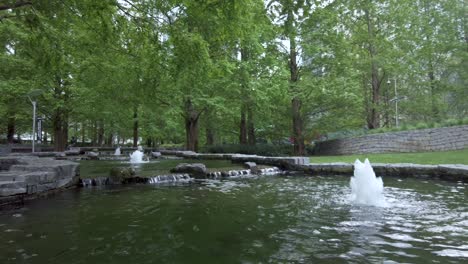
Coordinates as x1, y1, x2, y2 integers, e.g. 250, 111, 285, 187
350, 159, 386, 206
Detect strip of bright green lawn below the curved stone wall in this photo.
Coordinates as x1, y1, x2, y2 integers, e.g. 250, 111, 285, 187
310, 149, 468, 165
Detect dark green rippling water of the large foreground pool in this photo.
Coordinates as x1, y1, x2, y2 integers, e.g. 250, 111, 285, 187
0, 176, 468, 264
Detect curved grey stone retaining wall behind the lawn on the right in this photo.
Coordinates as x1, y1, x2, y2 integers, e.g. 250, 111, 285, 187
315, 125, 468, 155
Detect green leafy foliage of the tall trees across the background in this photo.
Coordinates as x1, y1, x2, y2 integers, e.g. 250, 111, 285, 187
0, 0, 468, 154
